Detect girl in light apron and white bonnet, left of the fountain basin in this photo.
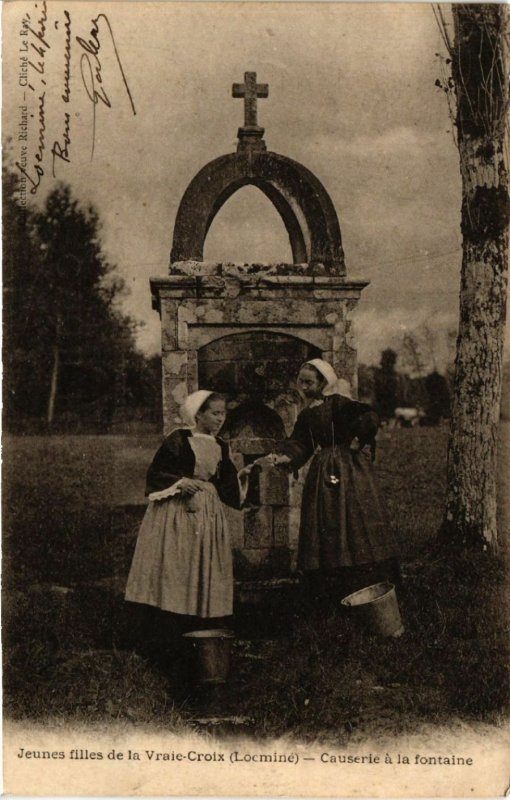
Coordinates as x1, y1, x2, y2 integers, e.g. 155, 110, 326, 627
125, 389, 250, 652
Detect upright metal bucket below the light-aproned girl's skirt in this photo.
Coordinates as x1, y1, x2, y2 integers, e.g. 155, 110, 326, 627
183, 628, 234, 683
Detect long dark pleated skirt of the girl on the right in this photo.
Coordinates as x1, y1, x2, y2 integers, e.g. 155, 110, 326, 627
298, 446, 398, 572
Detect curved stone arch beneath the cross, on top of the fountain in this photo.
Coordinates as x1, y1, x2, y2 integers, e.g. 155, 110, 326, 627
170, 151, 345, 275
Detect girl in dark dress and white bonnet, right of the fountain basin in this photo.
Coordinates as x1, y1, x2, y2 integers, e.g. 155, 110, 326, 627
269, 359, 399, 594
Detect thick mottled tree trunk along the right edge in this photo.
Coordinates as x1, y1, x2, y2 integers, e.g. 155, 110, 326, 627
439, 4, 509, 551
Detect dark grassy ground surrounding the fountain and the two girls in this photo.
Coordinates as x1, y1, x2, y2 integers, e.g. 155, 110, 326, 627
4, 428, 509, 744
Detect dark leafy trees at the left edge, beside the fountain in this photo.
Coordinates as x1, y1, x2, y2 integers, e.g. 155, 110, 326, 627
2, 164, 161, 433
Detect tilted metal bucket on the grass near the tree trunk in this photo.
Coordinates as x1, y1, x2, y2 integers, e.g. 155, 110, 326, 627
342, 583, 405, 638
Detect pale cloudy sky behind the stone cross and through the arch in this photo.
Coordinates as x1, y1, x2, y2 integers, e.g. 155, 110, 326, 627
3, 0, 486, 366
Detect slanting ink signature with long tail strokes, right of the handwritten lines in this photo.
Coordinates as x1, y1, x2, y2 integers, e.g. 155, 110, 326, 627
76, 14, 136, 160
